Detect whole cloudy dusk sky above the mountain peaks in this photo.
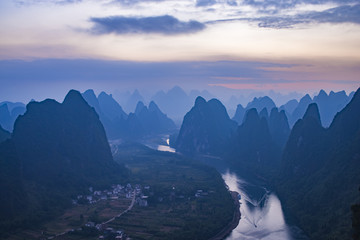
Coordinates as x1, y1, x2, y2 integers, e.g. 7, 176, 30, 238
0, 0, 360, 101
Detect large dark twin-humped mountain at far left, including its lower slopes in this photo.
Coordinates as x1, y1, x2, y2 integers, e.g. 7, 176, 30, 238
0, 90, 127, 232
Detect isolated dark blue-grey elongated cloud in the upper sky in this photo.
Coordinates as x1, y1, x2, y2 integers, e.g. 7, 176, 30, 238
90, 15, 205, 35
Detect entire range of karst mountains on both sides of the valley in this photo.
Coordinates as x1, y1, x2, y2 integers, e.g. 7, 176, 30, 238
0, 87, 360, 240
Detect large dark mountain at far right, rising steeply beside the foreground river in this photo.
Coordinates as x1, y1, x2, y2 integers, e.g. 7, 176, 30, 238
278, 89, 360, 239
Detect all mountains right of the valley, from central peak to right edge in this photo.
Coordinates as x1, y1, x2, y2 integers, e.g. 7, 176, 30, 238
176, 89, 360, 239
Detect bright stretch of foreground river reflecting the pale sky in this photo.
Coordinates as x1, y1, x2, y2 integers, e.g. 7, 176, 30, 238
222, 171, 292, 240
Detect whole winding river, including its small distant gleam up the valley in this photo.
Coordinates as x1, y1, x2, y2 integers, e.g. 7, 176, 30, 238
155, 137, 308, 240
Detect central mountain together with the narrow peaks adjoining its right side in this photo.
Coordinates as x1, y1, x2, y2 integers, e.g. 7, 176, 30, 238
175, 94, 290, 164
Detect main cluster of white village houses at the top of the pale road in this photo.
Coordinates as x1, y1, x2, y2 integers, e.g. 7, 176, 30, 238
72, 183, 150, 207
